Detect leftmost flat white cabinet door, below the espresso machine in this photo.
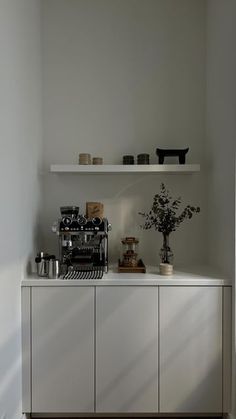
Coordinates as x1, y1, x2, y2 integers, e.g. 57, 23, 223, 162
32, 286, 94, 413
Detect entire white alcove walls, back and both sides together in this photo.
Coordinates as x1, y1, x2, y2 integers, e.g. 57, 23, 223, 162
0, 0, 233, 419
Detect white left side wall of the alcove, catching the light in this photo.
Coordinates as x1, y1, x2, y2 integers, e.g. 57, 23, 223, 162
0, 0, 42, 419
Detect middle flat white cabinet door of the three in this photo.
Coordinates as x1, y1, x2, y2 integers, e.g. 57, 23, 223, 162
96, 286, 158, 412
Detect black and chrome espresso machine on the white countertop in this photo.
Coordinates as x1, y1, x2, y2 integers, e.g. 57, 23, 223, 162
52, 206, 111, 279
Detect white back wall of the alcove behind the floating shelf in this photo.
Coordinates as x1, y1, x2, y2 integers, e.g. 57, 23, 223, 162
42, 0, 206, 265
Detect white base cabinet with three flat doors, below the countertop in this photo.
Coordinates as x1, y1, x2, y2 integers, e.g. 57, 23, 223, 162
22, 279, 231, 416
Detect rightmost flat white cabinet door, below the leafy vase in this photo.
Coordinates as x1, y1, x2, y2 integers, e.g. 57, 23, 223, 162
160, 287, 222, 413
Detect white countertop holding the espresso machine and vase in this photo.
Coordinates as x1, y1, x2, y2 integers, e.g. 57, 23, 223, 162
21, 266, 232, 287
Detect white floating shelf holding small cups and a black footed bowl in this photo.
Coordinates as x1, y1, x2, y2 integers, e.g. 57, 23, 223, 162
50, 164, 200, 174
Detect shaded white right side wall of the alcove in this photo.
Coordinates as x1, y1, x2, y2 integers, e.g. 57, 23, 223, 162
206, 0, 236, 415
